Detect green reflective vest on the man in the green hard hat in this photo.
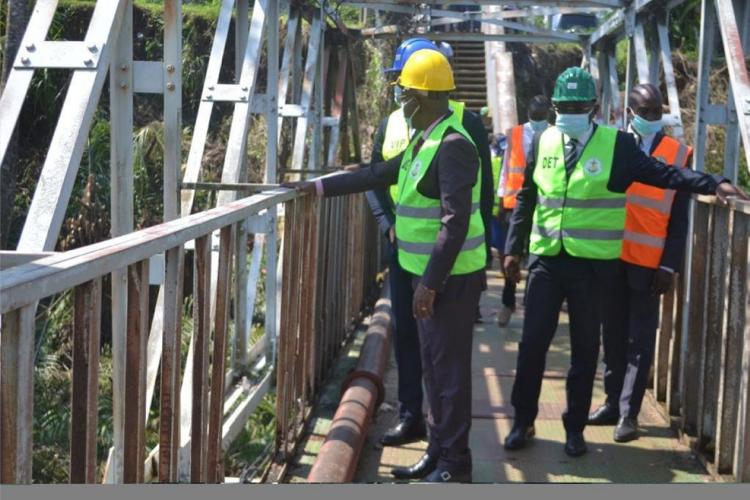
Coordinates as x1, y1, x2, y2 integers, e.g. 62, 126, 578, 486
529, 125, 625, 259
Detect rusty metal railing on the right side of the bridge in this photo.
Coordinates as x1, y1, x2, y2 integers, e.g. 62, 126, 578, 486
653, 196, 750, 482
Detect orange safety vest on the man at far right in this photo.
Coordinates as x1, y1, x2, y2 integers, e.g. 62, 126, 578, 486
620, 136, 692, 269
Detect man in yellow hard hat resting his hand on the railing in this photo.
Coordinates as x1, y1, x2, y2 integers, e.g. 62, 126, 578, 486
286, 50, 487, 482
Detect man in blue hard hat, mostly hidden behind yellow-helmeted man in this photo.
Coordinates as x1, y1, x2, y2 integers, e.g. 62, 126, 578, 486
367, 38, 494, 446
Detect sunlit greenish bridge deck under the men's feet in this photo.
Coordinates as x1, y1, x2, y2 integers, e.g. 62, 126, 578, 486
355, 264, 711, 483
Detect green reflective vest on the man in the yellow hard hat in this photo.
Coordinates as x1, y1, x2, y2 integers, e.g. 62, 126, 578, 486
396, 114, 487, 276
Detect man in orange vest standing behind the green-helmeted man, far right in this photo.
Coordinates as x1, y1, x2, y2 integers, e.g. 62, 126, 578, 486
588, 83, 692, 442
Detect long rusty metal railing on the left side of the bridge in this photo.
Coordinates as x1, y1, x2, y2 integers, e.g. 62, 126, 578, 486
0, 189, 380, 483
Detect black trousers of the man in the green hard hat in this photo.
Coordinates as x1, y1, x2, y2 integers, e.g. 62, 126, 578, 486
511, 254, 603, 432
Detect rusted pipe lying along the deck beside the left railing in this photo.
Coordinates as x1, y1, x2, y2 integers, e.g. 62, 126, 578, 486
307, 284, 392, 483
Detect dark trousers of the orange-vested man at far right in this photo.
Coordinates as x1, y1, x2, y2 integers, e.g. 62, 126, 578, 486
602, 266, 659, 418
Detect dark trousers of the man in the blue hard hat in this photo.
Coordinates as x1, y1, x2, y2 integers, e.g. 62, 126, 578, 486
388, 242, 424, 421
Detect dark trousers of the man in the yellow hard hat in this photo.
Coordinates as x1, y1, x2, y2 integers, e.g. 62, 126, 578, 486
414, 271, 486, 473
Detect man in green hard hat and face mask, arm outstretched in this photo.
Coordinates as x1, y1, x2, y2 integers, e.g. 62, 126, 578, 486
505, 67, 747, 456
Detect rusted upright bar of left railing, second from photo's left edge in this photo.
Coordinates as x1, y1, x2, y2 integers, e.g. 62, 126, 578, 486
70, 278, 102, 484
